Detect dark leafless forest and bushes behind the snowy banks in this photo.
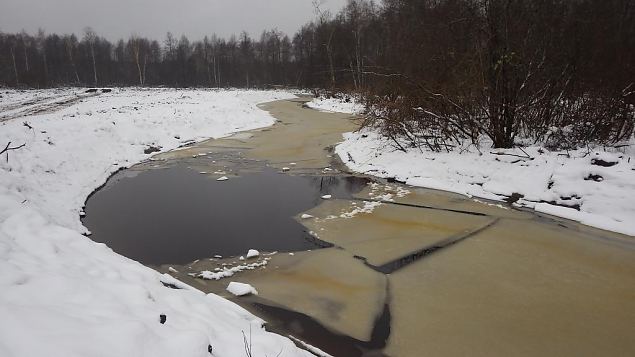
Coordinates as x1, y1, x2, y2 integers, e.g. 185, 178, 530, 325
0, 0, 635, 151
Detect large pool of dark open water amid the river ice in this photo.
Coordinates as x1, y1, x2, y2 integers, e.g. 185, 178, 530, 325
82, 166, 367, 265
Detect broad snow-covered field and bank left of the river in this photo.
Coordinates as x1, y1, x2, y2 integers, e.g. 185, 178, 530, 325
0, 89, 308, 357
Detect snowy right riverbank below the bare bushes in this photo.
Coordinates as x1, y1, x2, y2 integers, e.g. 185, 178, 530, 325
335, 129, 635, 235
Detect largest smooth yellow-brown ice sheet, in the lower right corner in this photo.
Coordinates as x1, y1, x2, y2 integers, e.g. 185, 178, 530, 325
386, 220, 635, 356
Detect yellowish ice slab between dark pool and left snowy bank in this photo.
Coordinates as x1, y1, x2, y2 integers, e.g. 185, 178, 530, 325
169, 248, 387, 341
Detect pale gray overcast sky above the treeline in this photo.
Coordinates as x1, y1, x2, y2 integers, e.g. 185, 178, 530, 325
0, 0, 346, 40
